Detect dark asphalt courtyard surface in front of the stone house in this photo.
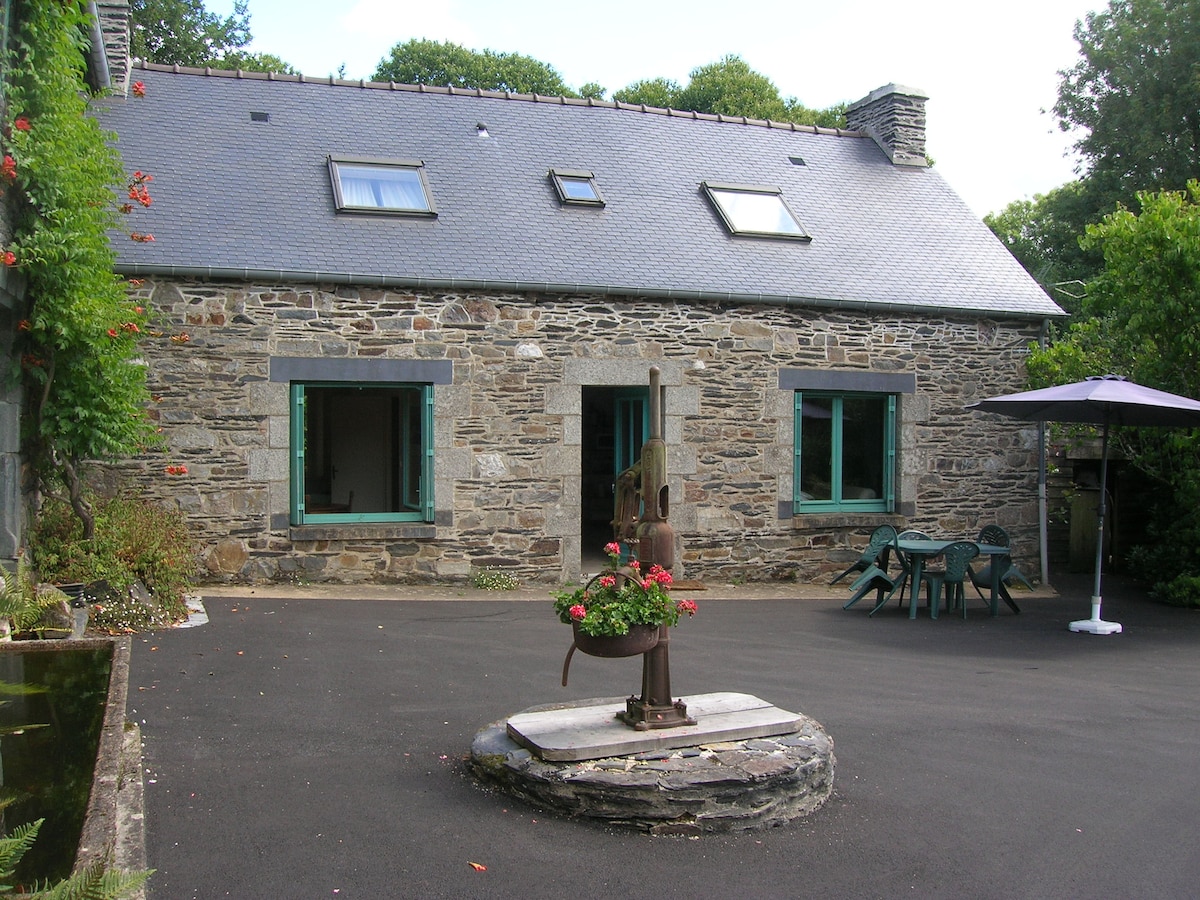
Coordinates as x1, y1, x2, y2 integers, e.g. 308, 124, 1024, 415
128, 576, 1200, 900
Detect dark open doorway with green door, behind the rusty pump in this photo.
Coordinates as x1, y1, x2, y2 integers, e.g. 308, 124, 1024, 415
580, 386, 649, 572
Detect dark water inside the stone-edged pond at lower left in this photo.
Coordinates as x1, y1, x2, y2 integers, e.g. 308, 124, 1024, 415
0, 646, 113, 884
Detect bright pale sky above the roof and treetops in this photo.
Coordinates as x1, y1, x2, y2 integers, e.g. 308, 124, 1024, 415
213, 0, 1108, 217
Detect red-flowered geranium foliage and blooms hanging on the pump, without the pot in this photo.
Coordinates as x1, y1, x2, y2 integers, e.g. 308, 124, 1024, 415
554, 541, 696, 637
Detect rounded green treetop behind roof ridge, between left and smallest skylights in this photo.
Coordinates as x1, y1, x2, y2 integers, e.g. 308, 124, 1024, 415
372, 38, 580, 97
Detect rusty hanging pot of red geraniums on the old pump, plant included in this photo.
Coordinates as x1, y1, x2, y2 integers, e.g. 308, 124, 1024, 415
554, 541, 696, 656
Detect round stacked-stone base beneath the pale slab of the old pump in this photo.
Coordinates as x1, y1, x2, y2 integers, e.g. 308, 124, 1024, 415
470, 708, 835, 834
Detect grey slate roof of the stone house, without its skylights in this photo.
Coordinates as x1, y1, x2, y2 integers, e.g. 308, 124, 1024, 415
97, 65, 1061, 318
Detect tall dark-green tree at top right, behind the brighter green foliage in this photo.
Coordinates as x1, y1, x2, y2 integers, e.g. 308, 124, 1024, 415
984, 0, 1200, 312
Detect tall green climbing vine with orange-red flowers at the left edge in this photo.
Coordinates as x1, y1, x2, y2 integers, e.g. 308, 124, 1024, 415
0, 0, 158, 538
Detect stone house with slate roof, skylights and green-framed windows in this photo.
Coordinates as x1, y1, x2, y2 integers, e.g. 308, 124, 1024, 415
97, 31, 1061, 582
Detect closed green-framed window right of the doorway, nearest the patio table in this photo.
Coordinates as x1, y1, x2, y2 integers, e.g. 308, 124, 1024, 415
792, 391, 896, 514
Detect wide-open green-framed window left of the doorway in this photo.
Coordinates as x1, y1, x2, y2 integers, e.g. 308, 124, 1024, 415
290, 380, 433, 524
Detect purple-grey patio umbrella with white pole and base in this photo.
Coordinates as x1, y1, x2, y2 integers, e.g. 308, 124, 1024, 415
967, 374, 1200, 635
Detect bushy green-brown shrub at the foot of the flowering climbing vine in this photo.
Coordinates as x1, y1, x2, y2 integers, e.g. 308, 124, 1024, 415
29, 496, 197, 631
